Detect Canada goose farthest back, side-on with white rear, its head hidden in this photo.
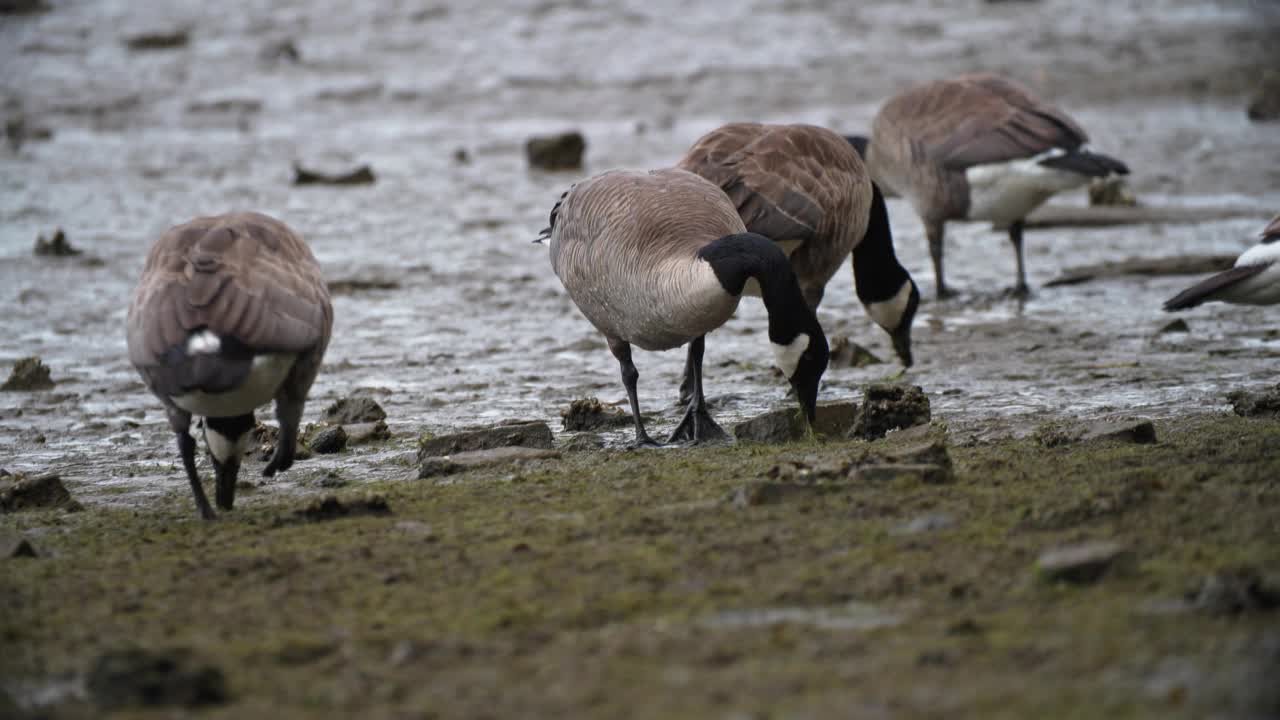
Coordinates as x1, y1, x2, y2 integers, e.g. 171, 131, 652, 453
847, 74, 1129, 297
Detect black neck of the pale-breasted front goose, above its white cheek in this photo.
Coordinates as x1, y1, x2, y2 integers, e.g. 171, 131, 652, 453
698, 233, 820, 345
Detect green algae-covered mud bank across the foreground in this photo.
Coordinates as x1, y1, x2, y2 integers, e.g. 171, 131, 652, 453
0, 414, 1280, 717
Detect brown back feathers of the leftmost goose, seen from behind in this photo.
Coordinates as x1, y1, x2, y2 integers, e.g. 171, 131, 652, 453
128, 213, 333, 366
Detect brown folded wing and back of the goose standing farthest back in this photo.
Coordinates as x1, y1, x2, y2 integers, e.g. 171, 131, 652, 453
881, 74, 1088, 170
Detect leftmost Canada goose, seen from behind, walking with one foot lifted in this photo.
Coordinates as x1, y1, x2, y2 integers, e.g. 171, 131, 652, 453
128, 213, 333, 519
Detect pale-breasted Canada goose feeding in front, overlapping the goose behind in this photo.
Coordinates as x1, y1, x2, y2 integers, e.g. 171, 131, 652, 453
539, 168, 828, 446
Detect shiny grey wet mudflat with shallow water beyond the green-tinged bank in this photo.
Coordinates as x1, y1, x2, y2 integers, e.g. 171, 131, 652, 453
0, 0, 1280, 498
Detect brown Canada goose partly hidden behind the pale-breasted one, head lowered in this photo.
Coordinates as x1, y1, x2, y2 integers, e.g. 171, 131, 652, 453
678, 123, 920, 368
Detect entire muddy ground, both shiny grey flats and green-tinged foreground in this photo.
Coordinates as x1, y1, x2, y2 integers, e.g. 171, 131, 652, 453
0, 0, 1280, 717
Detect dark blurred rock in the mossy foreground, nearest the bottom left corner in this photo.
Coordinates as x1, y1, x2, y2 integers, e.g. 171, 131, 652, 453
84, 648, 228, 710
